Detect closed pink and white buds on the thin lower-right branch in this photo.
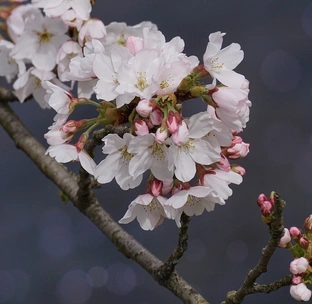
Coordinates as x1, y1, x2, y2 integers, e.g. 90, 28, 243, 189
257, 194, 312, 302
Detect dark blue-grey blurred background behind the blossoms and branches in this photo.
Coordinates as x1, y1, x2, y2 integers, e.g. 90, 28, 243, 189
0, 0, 312, 304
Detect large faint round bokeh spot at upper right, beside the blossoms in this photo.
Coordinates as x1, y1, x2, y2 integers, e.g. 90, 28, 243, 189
260, 50, 301, 92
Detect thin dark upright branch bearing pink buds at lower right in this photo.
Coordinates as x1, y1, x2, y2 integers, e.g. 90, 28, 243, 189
222, 193, 288, 304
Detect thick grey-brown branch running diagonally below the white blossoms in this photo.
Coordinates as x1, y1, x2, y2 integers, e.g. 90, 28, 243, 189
0, 102, 209, 304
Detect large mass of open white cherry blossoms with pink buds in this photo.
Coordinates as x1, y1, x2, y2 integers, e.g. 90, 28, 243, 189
0, 0, 251, 230
